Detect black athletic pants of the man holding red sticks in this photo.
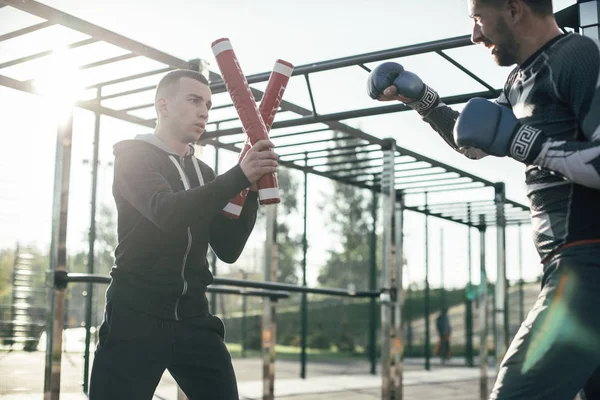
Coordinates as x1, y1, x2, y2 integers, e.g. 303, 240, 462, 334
89, 301, 239, 400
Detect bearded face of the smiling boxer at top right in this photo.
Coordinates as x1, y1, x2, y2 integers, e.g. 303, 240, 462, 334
469, 0, 519, 67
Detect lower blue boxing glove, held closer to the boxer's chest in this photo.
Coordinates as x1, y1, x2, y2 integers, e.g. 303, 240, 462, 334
454, 97, 546, 164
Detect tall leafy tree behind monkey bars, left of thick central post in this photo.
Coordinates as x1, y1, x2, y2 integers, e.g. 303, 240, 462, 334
318, 135, 372, 289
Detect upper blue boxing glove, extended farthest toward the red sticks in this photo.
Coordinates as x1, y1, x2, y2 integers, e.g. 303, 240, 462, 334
367, 62, 439, 115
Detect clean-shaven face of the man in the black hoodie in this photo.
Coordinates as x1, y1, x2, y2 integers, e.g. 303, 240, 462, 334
168, 77, 212, 143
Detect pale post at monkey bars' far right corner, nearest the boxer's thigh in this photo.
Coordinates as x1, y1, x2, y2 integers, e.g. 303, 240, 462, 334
494, 183, 509, 366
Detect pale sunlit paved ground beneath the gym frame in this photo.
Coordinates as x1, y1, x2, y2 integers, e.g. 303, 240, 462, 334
0, 351, 494, 400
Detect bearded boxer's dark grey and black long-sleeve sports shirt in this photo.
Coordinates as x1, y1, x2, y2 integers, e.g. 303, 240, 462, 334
423, 33, 600, 260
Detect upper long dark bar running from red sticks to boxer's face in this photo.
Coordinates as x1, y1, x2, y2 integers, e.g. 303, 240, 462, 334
211, 35, 473, 93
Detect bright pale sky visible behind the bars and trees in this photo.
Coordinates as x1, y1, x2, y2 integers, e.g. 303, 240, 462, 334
0, 0, 575, 286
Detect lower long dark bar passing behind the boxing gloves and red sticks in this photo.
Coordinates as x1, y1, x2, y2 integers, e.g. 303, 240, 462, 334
205, 91, 496, 144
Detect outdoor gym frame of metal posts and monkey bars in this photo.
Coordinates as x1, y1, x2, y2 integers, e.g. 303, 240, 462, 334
0, 0, 600, 399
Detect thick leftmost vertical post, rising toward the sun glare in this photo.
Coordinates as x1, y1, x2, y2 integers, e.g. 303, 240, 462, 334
44, 111, 73, 400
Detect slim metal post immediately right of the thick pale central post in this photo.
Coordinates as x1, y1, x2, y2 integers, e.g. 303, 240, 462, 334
392, 192, 404, 400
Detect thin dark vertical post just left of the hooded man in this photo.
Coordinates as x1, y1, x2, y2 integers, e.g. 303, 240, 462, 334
83, 87, 102, 394
